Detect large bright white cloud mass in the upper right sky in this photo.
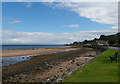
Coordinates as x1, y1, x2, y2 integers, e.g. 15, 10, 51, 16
46, 2, 118, 29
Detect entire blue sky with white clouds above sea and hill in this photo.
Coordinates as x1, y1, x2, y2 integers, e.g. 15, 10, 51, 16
0, 2, 118, 44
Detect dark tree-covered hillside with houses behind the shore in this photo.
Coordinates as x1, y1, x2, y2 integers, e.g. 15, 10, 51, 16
67, 32, 120, 47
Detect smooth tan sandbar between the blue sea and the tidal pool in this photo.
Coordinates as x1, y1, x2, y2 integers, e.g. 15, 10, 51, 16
0, 47, 79, 57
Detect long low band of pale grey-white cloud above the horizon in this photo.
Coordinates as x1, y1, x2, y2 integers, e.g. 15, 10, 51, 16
0, 30, 118, 44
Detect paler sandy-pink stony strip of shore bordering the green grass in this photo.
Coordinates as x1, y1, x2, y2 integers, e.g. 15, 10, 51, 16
42, 49, 100, 84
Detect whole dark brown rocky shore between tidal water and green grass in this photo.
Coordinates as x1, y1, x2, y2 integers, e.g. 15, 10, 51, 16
3, 48, 102, 83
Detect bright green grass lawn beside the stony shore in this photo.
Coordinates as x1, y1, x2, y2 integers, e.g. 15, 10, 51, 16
63, 49, 120, 82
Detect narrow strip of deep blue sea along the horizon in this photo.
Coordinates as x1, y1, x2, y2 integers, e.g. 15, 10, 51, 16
0, 45, 68, 50
